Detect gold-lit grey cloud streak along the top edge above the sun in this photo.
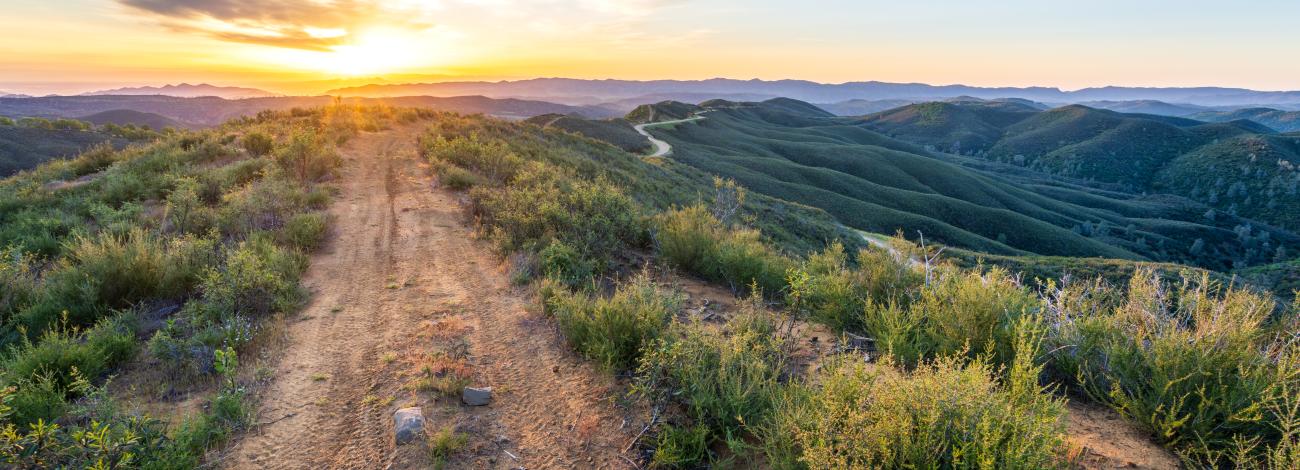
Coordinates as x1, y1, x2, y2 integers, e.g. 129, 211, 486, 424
116, 0, 697, 51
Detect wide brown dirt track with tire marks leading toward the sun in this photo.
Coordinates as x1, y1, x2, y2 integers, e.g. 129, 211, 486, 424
230, 125, 640, 469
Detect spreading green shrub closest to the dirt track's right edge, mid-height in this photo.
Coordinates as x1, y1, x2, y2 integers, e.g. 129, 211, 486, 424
543, 274, 683, 371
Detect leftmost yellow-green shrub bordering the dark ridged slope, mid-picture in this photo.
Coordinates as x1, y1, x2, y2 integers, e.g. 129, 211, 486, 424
655, 205, 794, 295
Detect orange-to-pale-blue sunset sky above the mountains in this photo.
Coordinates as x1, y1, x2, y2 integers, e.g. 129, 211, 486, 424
0, 0, 1300, 95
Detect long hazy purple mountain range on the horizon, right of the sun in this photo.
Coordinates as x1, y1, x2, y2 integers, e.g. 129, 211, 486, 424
328, 78, 1300, 109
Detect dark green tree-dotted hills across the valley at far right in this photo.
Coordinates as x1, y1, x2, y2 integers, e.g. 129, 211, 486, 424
863, 103, 1300, 231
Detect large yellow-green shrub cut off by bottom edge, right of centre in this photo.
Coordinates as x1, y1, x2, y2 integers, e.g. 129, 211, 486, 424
764, 322, 1065, 469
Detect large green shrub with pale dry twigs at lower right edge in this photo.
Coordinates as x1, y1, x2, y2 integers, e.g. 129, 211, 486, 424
1047, 271, 1300, 466
